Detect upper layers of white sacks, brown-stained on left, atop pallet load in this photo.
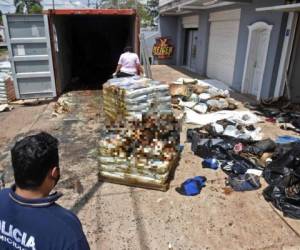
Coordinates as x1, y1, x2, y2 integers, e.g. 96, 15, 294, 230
103, 78, 172, 122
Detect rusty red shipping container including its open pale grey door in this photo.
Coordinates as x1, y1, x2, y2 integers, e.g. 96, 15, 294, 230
4, 9, 139, 99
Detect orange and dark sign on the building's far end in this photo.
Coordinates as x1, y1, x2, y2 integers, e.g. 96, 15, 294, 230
152, 37, 175, 59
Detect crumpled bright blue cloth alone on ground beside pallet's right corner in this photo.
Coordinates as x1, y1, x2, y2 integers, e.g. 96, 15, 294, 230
176, 176, 206, 196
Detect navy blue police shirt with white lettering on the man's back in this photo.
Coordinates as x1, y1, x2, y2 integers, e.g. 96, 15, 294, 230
0, 187, 90, 250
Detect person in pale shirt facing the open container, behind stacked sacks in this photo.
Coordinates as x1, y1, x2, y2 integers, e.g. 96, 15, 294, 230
113, 47, 143, 77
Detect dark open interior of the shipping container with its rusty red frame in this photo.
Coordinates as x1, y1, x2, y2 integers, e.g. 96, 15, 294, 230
47, 9, 140, 94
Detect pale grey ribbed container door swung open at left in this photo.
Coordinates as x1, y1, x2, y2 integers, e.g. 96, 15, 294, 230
3, 14, 56, 99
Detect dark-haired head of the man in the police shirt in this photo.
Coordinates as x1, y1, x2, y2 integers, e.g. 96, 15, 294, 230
11, 132, 60, 192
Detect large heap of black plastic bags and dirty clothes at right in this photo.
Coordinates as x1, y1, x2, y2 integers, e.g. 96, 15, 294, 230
187, 108, 300, 219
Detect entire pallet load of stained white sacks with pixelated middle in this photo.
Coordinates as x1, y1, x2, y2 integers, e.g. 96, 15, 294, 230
99, 78, 180, 191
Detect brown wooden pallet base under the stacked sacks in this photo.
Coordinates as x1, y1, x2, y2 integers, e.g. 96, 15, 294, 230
98, 154, 180, 192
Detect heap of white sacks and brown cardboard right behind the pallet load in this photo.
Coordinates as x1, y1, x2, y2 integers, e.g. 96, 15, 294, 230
170, 79, 237, 114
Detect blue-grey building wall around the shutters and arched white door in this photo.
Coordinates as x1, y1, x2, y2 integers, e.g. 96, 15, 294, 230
160, 0, 286, 98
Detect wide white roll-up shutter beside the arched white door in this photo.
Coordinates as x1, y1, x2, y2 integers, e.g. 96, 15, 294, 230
207, 9, 241, 85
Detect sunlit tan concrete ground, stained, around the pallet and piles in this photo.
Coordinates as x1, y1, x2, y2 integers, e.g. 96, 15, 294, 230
0, 66, 300, 250
